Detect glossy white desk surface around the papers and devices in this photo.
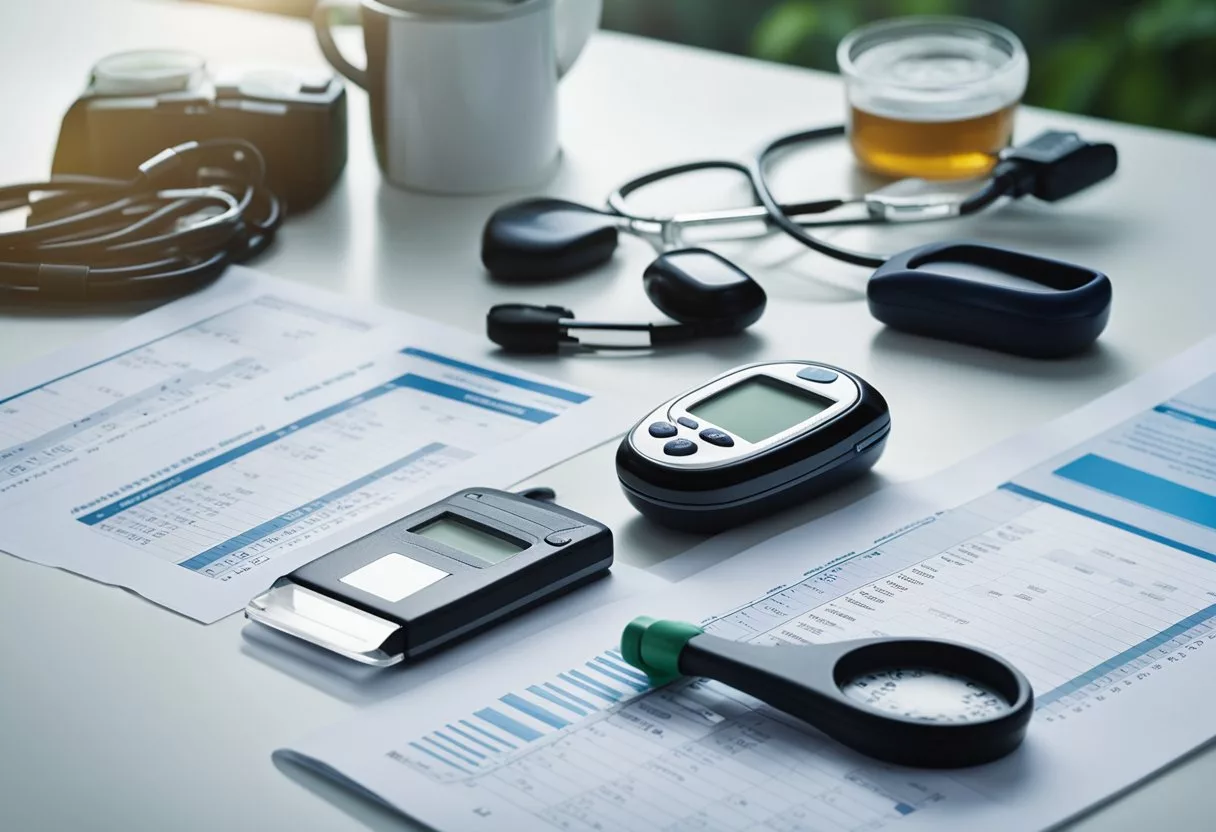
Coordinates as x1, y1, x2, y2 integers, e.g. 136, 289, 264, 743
0, 0, 1216, 832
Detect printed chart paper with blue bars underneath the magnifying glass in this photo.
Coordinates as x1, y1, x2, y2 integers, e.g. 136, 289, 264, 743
280, 338, 1216, 832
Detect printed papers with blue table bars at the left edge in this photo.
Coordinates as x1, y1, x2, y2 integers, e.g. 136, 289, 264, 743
0, 269, 629, 622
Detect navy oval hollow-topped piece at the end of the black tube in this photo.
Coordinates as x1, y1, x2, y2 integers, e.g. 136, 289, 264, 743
866, 242, 1111, 358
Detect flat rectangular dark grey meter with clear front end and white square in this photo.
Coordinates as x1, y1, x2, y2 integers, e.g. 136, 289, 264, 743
244, 488, 613, 667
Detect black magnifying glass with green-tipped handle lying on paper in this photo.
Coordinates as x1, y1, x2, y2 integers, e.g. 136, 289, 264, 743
621, 617, 1034, 769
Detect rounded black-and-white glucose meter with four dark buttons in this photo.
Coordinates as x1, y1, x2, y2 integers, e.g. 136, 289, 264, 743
617, 361, 891, 532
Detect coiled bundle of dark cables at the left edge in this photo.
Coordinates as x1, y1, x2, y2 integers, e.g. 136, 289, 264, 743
0, 139, 283, 305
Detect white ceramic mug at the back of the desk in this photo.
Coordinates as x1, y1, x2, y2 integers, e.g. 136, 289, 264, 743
313, 0, 602, 193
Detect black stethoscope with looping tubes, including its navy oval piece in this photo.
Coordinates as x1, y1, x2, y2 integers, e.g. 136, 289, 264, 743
482, 125, 1118, 358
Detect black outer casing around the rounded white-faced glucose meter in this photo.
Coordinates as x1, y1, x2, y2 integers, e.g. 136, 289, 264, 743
617, 362, 891, 533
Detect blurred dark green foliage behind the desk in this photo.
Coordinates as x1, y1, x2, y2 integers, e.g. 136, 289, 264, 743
603, 0, 1216, 136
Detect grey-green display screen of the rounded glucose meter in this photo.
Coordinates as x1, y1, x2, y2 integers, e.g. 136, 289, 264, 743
688, 376, 835, 442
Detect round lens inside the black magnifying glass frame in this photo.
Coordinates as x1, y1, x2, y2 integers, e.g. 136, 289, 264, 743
840, 667, 1012, 723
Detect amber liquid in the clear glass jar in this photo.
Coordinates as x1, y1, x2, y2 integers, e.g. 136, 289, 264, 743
849, 102, 1018, 179
